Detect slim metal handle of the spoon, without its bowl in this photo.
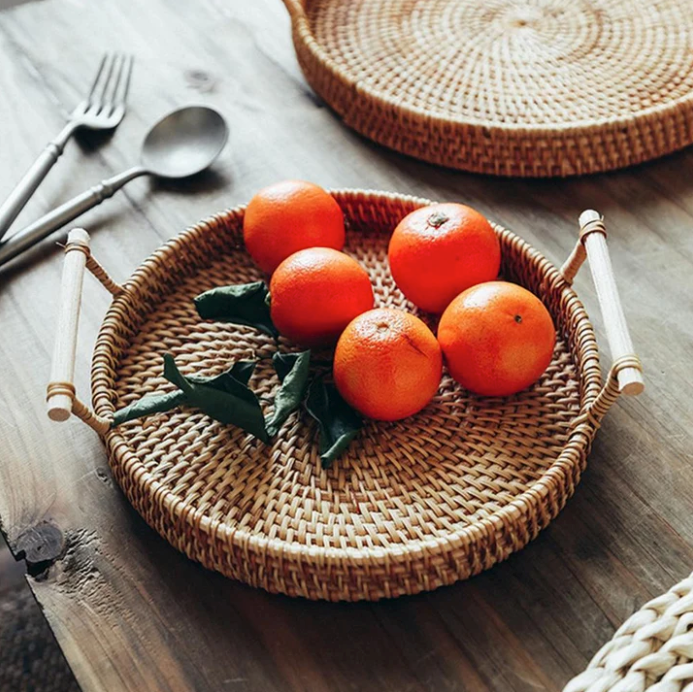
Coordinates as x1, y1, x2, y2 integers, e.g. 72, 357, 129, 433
0, 167, 148, 265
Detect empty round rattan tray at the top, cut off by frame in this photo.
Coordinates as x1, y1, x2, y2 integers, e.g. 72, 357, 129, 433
284, 0, 693, 176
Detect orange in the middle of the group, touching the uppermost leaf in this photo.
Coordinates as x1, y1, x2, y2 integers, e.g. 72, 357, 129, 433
270, 247, 373, 347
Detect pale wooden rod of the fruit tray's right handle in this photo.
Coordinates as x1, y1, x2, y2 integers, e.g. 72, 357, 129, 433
579, 209, 645, 396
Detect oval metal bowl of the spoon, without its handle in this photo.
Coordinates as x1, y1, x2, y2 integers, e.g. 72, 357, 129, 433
141, 106, 228, 178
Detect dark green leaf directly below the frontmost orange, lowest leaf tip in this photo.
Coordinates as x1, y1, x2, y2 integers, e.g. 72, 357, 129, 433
306, 378, 363, 469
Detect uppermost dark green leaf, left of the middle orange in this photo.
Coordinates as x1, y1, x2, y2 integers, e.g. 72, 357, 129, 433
195, 281, 279, 338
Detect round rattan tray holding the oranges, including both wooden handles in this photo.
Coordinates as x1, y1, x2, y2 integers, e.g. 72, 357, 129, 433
48, 191, 642, 600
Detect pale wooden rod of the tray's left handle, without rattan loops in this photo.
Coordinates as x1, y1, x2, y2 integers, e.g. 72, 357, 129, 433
47, 228, 89, 421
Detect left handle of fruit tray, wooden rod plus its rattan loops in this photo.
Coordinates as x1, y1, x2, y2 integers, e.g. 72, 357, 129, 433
46, 228, 122, 435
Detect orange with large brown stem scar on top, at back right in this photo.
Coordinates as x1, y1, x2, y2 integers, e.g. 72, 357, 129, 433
388, 203, 501, 313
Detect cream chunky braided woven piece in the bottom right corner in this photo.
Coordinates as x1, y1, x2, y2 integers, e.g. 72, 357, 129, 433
564, 574, 693, 692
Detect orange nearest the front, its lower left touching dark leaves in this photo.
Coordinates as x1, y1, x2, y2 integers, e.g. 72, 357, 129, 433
334, 309, 443, 420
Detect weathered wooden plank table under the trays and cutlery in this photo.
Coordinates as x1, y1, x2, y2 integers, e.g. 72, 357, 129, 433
0, 0, 693, 692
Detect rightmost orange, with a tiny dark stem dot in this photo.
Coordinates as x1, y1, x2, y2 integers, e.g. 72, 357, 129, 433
438, 281, 556, 396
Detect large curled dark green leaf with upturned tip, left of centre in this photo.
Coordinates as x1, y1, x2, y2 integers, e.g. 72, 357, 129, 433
164, 353, 269, 442
